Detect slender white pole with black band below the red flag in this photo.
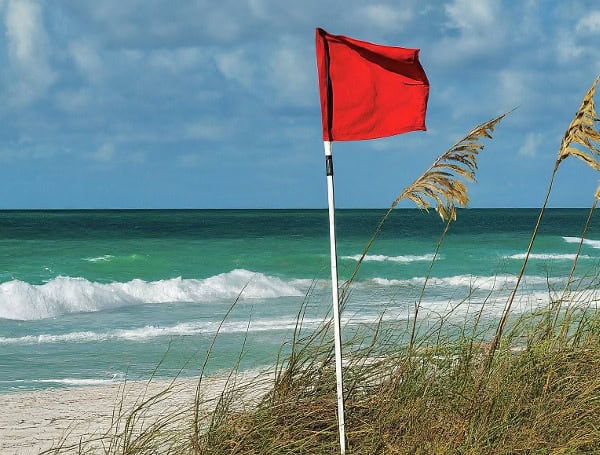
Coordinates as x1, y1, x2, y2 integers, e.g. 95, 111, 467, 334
323, 141, 346, 455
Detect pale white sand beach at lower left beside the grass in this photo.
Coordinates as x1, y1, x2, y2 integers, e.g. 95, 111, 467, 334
0, 373, 269, 455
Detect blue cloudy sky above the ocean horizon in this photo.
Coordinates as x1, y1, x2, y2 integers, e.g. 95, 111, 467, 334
0, 0, 600, 209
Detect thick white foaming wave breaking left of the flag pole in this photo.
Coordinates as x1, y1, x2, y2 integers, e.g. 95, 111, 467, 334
0, 269, 308, 320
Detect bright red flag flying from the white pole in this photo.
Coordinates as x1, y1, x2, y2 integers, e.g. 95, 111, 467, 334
316, 28, 429, 141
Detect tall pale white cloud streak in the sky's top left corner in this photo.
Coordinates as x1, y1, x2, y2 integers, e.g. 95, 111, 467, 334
4, 0, 56, 105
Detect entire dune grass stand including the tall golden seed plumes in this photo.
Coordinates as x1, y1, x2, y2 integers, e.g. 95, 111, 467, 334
44, 80, 600, 455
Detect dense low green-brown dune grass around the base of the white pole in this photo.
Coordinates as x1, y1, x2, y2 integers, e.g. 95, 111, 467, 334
190, 292, 600, 454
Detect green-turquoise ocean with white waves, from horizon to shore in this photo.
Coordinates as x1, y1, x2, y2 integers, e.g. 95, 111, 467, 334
0, 209, 600, 393
